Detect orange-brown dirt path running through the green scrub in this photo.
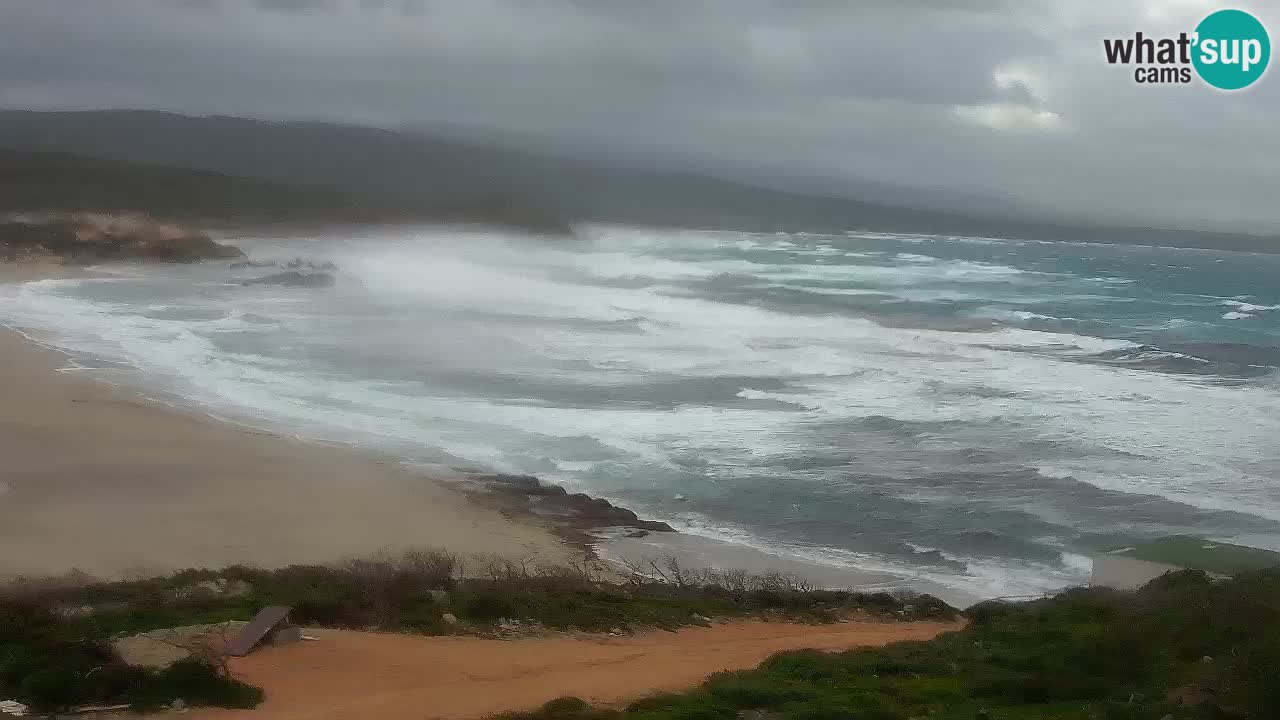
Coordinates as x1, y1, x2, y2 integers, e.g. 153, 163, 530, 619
180, 621, 959, 720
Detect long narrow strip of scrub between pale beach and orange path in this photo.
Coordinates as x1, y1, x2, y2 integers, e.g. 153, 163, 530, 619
7, 552, 956, 637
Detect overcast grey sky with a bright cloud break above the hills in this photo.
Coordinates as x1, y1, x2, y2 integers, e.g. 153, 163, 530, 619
0, 0, 1280, 231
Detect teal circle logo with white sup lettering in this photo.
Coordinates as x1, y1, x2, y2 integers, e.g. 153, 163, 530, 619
1192, 10, 1271, 90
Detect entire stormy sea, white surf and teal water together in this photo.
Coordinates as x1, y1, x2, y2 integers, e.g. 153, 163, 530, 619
0, 227, 1280, 596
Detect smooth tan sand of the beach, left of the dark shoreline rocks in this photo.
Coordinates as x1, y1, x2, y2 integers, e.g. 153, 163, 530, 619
0, 265, 576, 578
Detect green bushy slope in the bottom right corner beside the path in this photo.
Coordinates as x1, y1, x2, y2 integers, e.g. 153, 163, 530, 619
491, 569, 1280, 720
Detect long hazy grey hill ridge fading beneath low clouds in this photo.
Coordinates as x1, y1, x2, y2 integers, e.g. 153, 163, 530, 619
0, 110, 1280, 252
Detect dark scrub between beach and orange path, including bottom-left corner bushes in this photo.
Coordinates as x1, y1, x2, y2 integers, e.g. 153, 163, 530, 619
0, 552, 956, 711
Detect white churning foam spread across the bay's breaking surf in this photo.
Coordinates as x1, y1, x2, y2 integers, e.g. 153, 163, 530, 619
10, 228, 1280, 594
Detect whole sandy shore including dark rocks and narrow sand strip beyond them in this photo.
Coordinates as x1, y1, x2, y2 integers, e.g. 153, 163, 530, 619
0, 263, 978, 606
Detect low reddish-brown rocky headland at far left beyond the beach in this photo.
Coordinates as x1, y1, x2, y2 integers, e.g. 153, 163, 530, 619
0, 213, 243, 264
